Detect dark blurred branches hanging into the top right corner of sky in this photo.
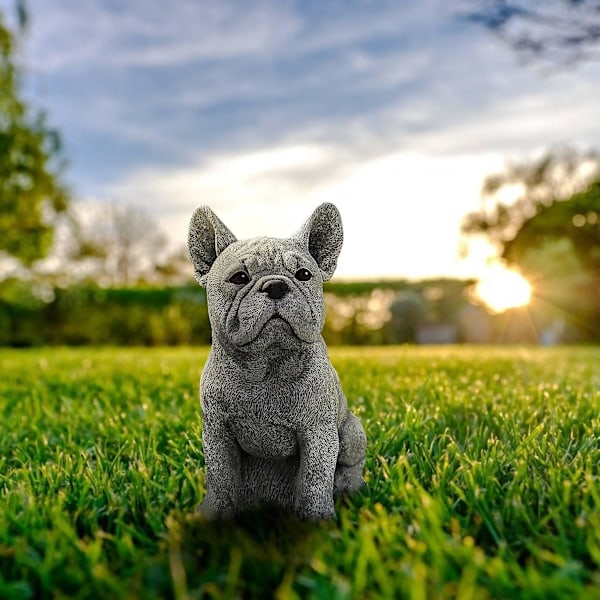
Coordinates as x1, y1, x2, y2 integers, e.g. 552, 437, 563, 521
464, 0, 600, 65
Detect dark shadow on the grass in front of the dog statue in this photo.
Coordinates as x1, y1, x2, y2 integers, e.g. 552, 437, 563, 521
167, 506, 336, 598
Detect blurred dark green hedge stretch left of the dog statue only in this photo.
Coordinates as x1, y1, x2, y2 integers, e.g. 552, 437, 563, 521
0, 282, 210, 346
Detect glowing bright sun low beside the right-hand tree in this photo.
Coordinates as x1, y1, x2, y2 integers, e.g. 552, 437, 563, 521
475, 264, 531, 313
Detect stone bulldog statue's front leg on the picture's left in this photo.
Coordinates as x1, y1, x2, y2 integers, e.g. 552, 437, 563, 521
198, 411, 241, 518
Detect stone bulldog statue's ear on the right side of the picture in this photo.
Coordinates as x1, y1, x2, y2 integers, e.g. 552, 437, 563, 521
294, 203, 344, 281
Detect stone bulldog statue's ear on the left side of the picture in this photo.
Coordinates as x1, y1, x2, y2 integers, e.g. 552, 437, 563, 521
188, 206, 236, 285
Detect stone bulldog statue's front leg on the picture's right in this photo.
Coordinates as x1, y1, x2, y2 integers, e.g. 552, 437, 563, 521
294, 423, 339, 521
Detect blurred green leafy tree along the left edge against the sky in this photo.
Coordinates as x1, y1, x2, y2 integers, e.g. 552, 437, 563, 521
0, 9, 68, 266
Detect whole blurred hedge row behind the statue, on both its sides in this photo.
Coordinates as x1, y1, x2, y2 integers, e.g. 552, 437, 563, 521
0, 279, 600, 347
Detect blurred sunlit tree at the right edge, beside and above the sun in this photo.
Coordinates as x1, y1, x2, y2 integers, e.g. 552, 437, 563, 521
463, 151, 600, 339
